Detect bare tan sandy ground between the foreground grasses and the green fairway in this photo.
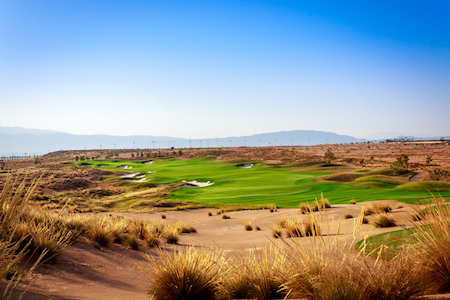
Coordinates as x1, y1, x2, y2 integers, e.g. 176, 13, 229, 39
21, 200, 450, 300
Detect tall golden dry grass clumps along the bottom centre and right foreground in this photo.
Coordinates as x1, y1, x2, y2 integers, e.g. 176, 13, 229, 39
144, 195, 450, 299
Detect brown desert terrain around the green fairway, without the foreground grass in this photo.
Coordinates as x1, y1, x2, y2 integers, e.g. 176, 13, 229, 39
0, 142, 450, 299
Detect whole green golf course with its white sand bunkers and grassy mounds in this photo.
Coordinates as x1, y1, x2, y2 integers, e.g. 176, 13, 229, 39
77, 158, 450, 208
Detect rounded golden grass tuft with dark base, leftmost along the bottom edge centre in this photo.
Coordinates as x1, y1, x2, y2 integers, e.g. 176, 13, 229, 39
141, 247, 224, 300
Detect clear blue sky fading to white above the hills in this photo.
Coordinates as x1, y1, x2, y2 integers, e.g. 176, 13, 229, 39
0, 0, 450, 138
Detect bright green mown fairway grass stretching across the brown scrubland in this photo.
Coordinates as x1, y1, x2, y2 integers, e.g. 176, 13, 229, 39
79, 159, 450, 207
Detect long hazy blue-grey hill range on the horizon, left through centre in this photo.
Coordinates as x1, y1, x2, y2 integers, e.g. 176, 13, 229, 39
0, 126, 363, 156
